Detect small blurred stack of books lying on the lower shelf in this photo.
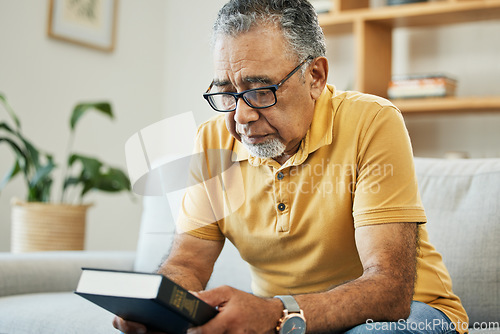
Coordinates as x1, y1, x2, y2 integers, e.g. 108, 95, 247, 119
387, 74, 457, 99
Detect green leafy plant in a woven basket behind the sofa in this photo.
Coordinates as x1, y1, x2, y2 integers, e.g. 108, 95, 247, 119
0, 93, 130, 252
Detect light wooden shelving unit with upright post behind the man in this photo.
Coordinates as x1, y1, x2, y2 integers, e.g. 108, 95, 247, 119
318, 0, 500, 113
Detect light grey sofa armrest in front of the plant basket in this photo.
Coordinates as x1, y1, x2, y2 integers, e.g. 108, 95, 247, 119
0, 251, 135, 297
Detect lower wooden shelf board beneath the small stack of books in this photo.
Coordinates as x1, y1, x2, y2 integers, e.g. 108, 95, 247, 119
392, 96, 500, 113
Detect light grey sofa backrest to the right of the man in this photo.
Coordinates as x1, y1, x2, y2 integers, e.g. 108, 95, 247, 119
415, 158, 500, 324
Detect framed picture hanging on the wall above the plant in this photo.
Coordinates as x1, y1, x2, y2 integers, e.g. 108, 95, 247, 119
48, 0, 118, 52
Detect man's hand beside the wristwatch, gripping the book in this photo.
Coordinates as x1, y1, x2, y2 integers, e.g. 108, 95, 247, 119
188, 286, 283, 334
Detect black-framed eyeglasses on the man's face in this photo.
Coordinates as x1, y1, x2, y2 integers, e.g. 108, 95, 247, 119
203, 56, 314, 112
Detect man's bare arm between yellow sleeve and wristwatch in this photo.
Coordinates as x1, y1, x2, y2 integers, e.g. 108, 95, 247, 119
296, 223, 418, 332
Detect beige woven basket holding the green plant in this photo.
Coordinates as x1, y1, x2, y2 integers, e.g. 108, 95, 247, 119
11, 200, 90, 253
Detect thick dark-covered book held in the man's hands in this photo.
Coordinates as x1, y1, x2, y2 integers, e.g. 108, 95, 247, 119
75, 268, 218, 334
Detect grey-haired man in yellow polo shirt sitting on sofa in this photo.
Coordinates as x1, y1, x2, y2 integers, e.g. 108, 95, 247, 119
114, 0, 467, 334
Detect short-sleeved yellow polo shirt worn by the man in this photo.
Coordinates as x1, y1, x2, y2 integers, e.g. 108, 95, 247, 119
178, 85, 468, 332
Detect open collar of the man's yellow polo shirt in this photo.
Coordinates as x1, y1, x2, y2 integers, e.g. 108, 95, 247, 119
233, 85, 335, 167
